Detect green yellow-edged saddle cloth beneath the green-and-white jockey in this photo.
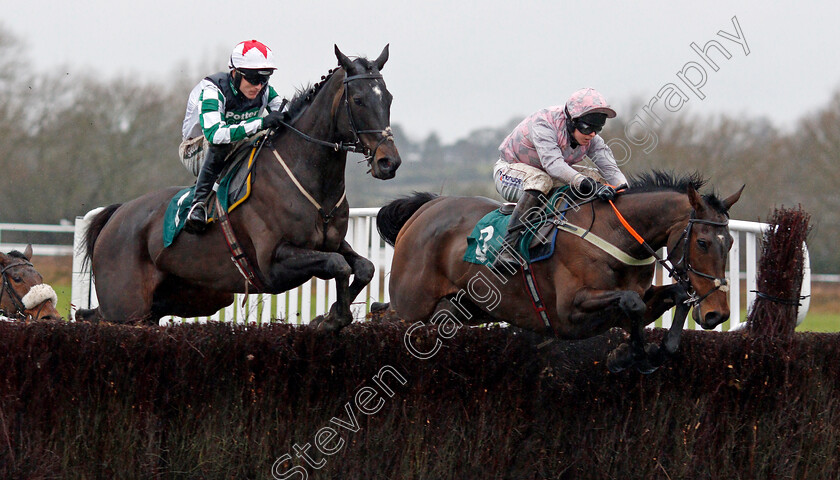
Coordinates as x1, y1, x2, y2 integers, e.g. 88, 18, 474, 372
163, 136, 264, 248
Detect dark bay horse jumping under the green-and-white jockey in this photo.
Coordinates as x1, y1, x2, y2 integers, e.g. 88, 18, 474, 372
77, 45, 401, 329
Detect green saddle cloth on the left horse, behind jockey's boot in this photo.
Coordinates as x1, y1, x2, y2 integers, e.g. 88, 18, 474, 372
163, 151, 254, 248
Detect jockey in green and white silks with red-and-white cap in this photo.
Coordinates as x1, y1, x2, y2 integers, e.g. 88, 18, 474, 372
180, 40, 283, 233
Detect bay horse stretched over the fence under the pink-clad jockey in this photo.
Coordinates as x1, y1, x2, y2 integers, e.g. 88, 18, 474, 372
377, 171, 744, 373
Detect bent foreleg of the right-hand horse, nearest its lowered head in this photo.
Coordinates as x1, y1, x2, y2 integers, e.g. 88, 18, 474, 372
645, 284, 689, 367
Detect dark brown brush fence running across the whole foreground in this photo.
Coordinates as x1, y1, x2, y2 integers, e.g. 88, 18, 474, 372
0, 323, 840, 479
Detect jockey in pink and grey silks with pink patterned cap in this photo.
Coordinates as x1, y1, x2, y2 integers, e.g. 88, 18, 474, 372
493, 88, 627, 270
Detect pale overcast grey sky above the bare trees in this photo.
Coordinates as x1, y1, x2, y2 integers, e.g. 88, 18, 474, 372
0, 0, 840, 142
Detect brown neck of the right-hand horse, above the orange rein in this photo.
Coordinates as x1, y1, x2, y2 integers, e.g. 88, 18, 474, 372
619, 192, 691, 250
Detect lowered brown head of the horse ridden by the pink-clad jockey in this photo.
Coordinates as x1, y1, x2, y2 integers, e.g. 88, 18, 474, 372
668, 185, 744, 329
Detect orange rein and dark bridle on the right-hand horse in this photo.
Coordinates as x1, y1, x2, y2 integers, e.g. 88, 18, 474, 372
609, 200, 729, 307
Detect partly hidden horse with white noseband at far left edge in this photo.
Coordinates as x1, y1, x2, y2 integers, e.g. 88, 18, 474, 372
0, 245, 61, 320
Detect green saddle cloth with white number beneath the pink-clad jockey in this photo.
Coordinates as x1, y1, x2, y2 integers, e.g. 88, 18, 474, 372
464, 186, 569, 265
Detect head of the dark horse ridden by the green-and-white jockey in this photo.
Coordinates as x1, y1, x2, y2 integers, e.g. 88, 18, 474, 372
335, 45, 402, 180
